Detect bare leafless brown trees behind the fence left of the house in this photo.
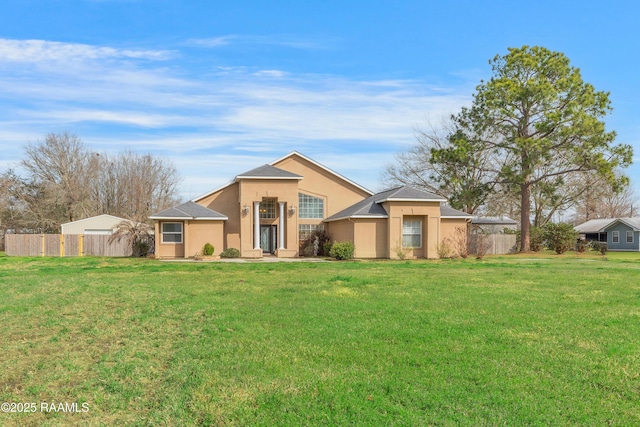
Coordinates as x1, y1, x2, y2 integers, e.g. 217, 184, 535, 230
0, 132, 180, 233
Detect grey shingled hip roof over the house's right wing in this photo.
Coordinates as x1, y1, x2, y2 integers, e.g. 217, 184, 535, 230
325, 186, 464, 222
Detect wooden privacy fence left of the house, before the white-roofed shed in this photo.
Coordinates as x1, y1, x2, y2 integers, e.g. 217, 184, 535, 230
5, 234, 131, 257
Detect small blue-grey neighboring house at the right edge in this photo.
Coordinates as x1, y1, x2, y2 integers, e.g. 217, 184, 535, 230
574, 217, 640, 251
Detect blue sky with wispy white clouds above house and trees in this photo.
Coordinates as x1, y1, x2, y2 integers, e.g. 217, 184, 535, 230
0, 0, 640, 199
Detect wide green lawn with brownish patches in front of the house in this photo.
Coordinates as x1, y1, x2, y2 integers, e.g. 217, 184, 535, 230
0, 253, 640, 426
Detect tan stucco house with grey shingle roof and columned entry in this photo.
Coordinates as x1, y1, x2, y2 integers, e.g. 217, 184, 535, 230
150, 151, 471, 258
